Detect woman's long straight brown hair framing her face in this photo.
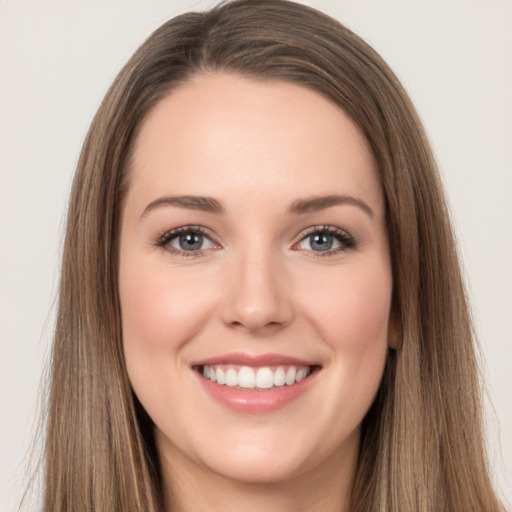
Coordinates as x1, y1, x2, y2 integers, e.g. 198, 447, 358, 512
44, 0, 501, 512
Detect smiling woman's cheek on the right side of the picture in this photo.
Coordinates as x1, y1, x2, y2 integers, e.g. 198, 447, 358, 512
300, 266, 392, 398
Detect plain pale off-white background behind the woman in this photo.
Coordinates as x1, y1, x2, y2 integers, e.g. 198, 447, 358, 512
0, 0, 512, 512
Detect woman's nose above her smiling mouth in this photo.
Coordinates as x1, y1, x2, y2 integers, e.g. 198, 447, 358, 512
222, 248, 294, 334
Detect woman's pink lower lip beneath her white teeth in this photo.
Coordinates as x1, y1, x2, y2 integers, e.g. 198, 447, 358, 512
195, 371, 319, 414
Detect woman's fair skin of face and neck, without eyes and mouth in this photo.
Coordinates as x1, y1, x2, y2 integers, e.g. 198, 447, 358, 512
119, 73, 392, 512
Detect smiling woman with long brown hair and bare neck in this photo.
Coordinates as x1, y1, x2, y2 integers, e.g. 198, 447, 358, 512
40, 0, 500, 511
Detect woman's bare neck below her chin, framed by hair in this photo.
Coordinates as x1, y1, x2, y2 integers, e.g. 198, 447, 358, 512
161, 432, 358, 512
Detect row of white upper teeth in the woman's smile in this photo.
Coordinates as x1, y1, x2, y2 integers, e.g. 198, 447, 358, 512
203, 365, 311, 389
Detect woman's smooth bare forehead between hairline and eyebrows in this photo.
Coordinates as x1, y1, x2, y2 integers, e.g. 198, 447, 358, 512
129, 73, 382, 214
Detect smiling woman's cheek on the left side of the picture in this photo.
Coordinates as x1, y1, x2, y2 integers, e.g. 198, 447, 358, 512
119, 251, 221, 432
